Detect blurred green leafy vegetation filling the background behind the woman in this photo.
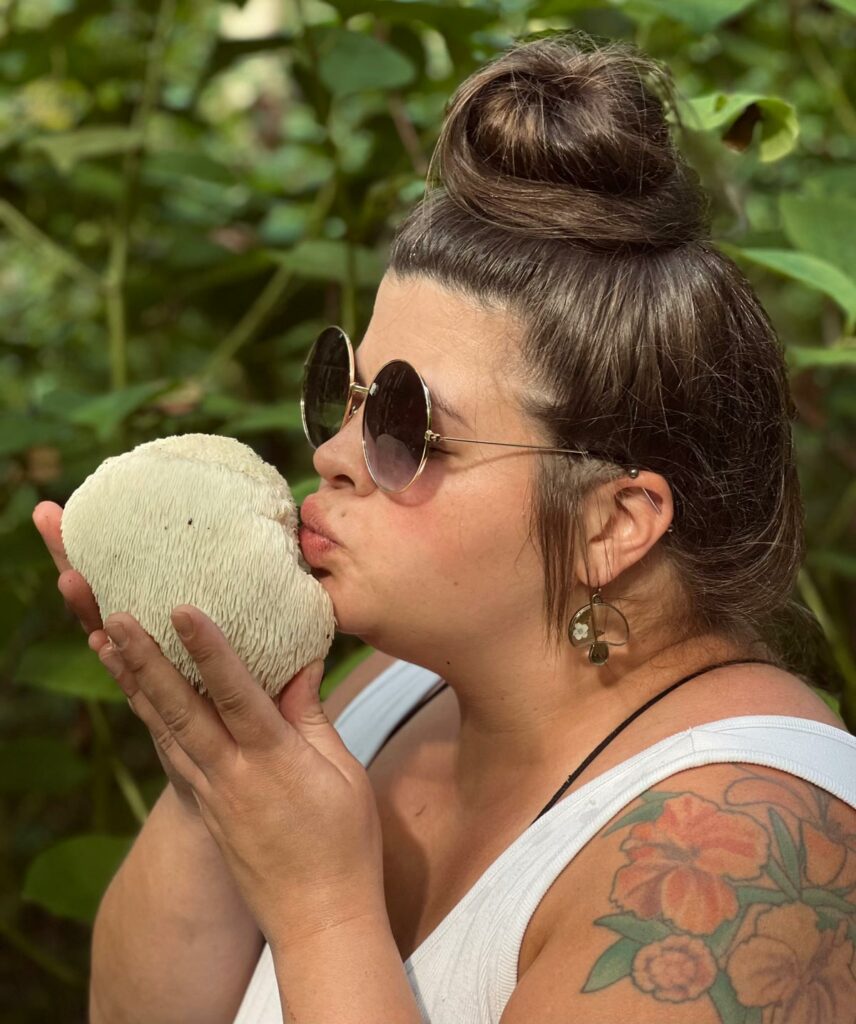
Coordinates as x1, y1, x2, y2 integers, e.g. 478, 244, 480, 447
0, 0, 856, 1024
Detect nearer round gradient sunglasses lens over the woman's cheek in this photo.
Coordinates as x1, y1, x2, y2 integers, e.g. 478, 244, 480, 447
362, 359, 428, 490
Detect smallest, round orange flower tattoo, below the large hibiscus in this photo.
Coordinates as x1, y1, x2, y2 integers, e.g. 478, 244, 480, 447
633, 935, 718, 1002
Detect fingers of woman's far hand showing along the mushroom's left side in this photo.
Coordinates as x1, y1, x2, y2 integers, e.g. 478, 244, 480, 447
33, 502, 206, 818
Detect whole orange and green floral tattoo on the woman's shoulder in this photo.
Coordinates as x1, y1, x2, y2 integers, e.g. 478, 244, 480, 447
583, 765, 856, 1024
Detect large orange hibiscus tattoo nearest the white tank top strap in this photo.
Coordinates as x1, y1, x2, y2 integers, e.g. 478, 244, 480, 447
610, 794, 769, 935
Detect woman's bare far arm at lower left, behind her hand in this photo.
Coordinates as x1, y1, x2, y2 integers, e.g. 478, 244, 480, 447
89, 785, 264, 1024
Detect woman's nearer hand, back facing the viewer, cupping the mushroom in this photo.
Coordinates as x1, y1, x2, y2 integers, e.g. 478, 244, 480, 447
96, 604, 388, 946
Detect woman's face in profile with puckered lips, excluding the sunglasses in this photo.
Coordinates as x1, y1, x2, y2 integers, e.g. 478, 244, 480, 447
311, 273, 545, 664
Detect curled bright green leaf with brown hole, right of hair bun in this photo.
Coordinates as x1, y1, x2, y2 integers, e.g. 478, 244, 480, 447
678, 92, 800, 163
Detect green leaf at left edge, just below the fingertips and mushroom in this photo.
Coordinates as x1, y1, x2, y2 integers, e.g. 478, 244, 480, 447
13, 633, 125, 703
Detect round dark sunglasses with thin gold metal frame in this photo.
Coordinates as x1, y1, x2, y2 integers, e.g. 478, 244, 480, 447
300, 326, 660, 503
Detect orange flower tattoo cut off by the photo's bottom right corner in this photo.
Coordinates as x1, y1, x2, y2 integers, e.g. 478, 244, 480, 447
727, 903, 856, 1024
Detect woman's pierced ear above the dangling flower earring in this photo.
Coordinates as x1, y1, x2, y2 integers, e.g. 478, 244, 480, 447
574, 471, 674, 587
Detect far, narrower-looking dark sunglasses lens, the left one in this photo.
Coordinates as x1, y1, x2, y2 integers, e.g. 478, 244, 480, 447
301, 327, 350, 447
